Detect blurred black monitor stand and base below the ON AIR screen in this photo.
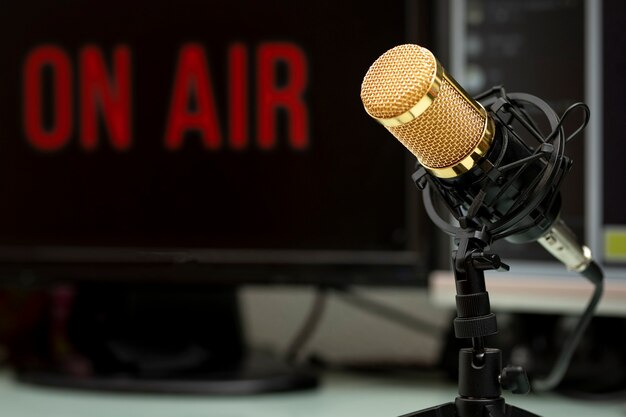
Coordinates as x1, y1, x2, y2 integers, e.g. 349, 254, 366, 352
17, 282, 318, 394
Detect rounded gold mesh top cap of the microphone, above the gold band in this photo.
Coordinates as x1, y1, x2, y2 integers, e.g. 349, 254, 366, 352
361, 44, 437, 119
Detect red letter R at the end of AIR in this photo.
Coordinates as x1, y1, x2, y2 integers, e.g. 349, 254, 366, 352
257, 43, 309, 149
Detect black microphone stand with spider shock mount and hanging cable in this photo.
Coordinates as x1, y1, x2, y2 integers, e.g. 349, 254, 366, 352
392, 87, 603, 417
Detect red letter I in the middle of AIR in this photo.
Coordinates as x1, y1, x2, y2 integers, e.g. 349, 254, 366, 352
228, 44, 248, 150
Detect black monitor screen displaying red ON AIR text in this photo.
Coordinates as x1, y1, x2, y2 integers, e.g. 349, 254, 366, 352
0, 1, 422, 282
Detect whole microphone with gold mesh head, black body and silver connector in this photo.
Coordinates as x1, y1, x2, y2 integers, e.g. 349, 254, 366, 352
361, 45, 592, 272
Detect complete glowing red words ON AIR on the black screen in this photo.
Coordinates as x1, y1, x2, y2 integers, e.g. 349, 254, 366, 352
22, 42, 309, 152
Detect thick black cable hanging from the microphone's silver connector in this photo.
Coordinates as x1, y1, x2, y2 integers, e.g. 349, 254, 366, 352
532, 262, 604, 392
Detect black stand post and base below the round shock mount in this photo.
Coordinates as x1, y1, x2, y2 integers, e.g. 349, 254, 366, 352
402, 228, 538, 417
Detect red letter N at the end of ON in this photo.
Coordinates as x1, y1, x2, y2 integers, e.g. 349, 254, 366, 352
79, 46, 131, 151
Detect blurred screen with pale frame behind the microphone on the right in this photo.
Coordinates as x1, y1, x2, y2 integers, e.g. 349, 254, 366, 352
431, 0, 626, 316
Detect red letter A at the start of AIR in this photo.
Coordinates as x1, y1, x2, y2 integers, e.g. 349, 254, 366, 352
165, 44, 222, 150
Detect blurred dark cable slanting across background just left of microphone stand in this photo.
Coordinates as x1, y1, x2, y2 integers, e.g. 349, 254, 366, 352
336, 289, 442, 336
